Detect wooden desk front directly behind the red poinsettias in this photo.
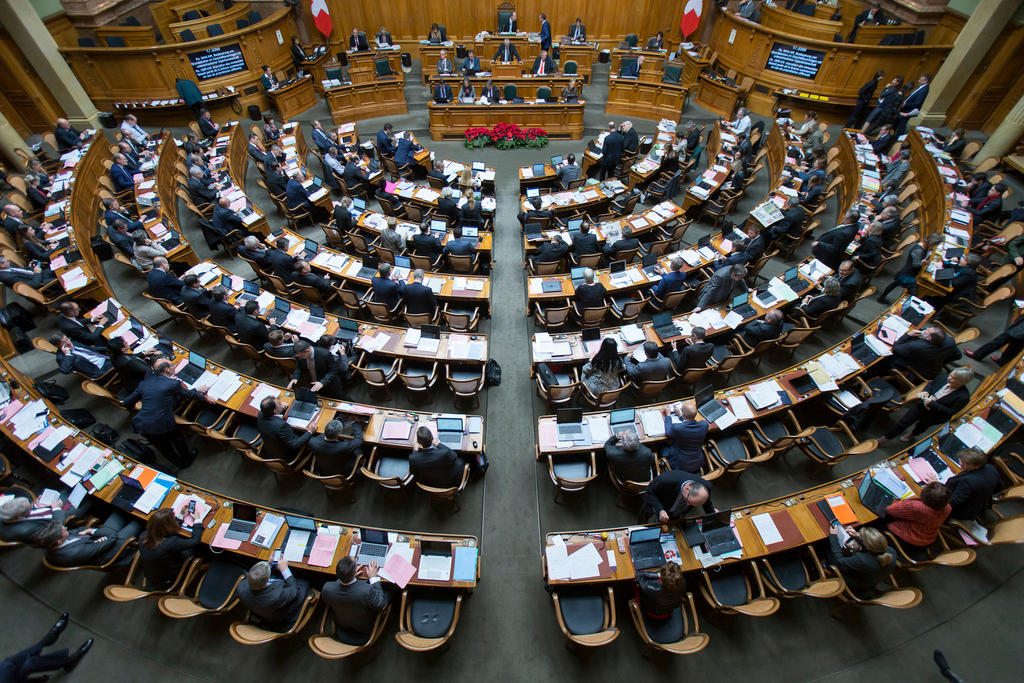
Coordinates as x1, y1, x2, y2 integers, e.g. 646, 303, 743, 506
425, 101, 586, 140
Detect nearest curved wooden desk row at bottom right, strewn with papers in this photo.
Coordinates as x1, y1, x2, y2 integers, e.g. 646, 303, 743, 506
541, 358, 1022, 586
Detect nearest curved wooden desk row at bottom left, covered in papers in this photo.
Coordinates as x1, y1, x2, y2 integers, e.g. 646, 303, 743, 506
0, 361, 480, 590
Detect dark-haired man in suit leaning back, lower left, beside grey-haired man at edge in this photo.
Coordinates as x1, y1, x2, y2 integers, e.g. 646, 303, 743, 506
32, 511, 142, 567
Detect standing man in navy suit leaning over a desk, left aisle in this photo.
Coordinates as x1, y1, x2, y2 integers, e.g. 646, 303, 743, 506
124, 358, 212, 468
